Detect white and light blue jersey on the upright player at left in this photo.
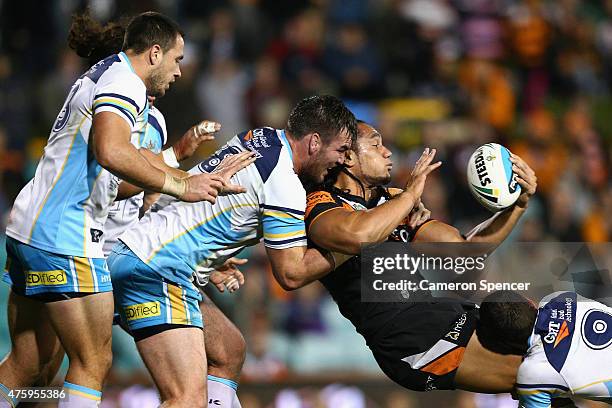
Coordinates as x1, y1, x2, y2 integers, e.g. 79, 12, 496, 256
7, 53, 148, 258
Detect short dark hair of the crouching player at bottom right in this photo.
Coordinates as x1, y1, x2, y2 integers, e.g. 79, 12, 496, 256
476, 290, 537, 356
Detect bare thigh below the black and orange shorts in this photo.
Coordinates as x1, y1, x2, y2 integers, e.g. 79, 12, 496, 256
455, 333, 521, 393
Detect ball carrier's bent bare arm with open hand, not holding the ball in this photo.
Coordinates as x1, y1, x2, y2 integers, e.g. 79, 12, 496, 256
308, 149, 441, 255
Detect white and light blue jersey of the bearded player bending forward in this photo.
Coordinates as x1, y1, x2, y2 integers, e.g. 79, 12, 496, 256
120, 128, 306, 285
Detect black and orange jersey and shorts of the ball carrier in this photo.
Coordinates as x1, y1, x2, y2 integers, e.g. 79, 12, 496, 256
305, 188, 478, 391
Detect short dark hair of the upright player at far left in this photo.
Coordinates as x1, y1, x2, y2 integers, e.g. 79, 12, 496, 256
123, 11, 185, 54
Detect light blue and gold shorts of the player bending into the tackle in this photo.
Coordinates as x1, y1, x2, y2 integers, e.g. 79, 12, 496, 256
108, 242, 203, 330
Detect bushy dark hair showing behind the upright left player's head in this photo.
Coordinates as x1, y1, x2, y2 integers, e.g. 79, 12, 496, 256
68, 11, 126, 66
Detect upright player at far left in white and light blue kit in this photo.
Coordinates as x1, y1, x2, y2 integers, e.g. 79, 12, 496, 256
0, 12, 253, 407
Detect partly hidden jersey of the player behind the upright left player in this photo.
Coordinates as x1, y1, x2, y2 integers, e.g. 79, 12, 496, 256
103, 106, 168, 256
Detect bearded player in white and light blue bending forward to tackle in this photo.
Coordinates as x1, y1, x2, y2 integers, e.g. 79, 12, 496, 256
108, 96, 356, 407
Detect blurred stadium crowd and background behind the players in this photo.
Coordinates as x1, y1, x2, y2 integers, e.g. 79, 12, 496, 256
0, 0, 612, 407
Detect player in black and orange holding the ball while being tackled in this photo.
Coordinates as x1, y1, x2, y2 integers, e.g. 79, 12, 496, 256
277, 122, 536, 393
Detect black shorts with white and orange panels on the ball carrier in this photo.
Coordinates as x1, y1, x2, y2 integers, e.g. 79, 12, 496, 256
368, 302, 478, 391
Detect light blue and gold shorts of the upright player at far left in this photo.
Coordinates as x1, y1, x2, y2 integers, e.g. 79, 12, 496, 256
3, 237, 113, 296
